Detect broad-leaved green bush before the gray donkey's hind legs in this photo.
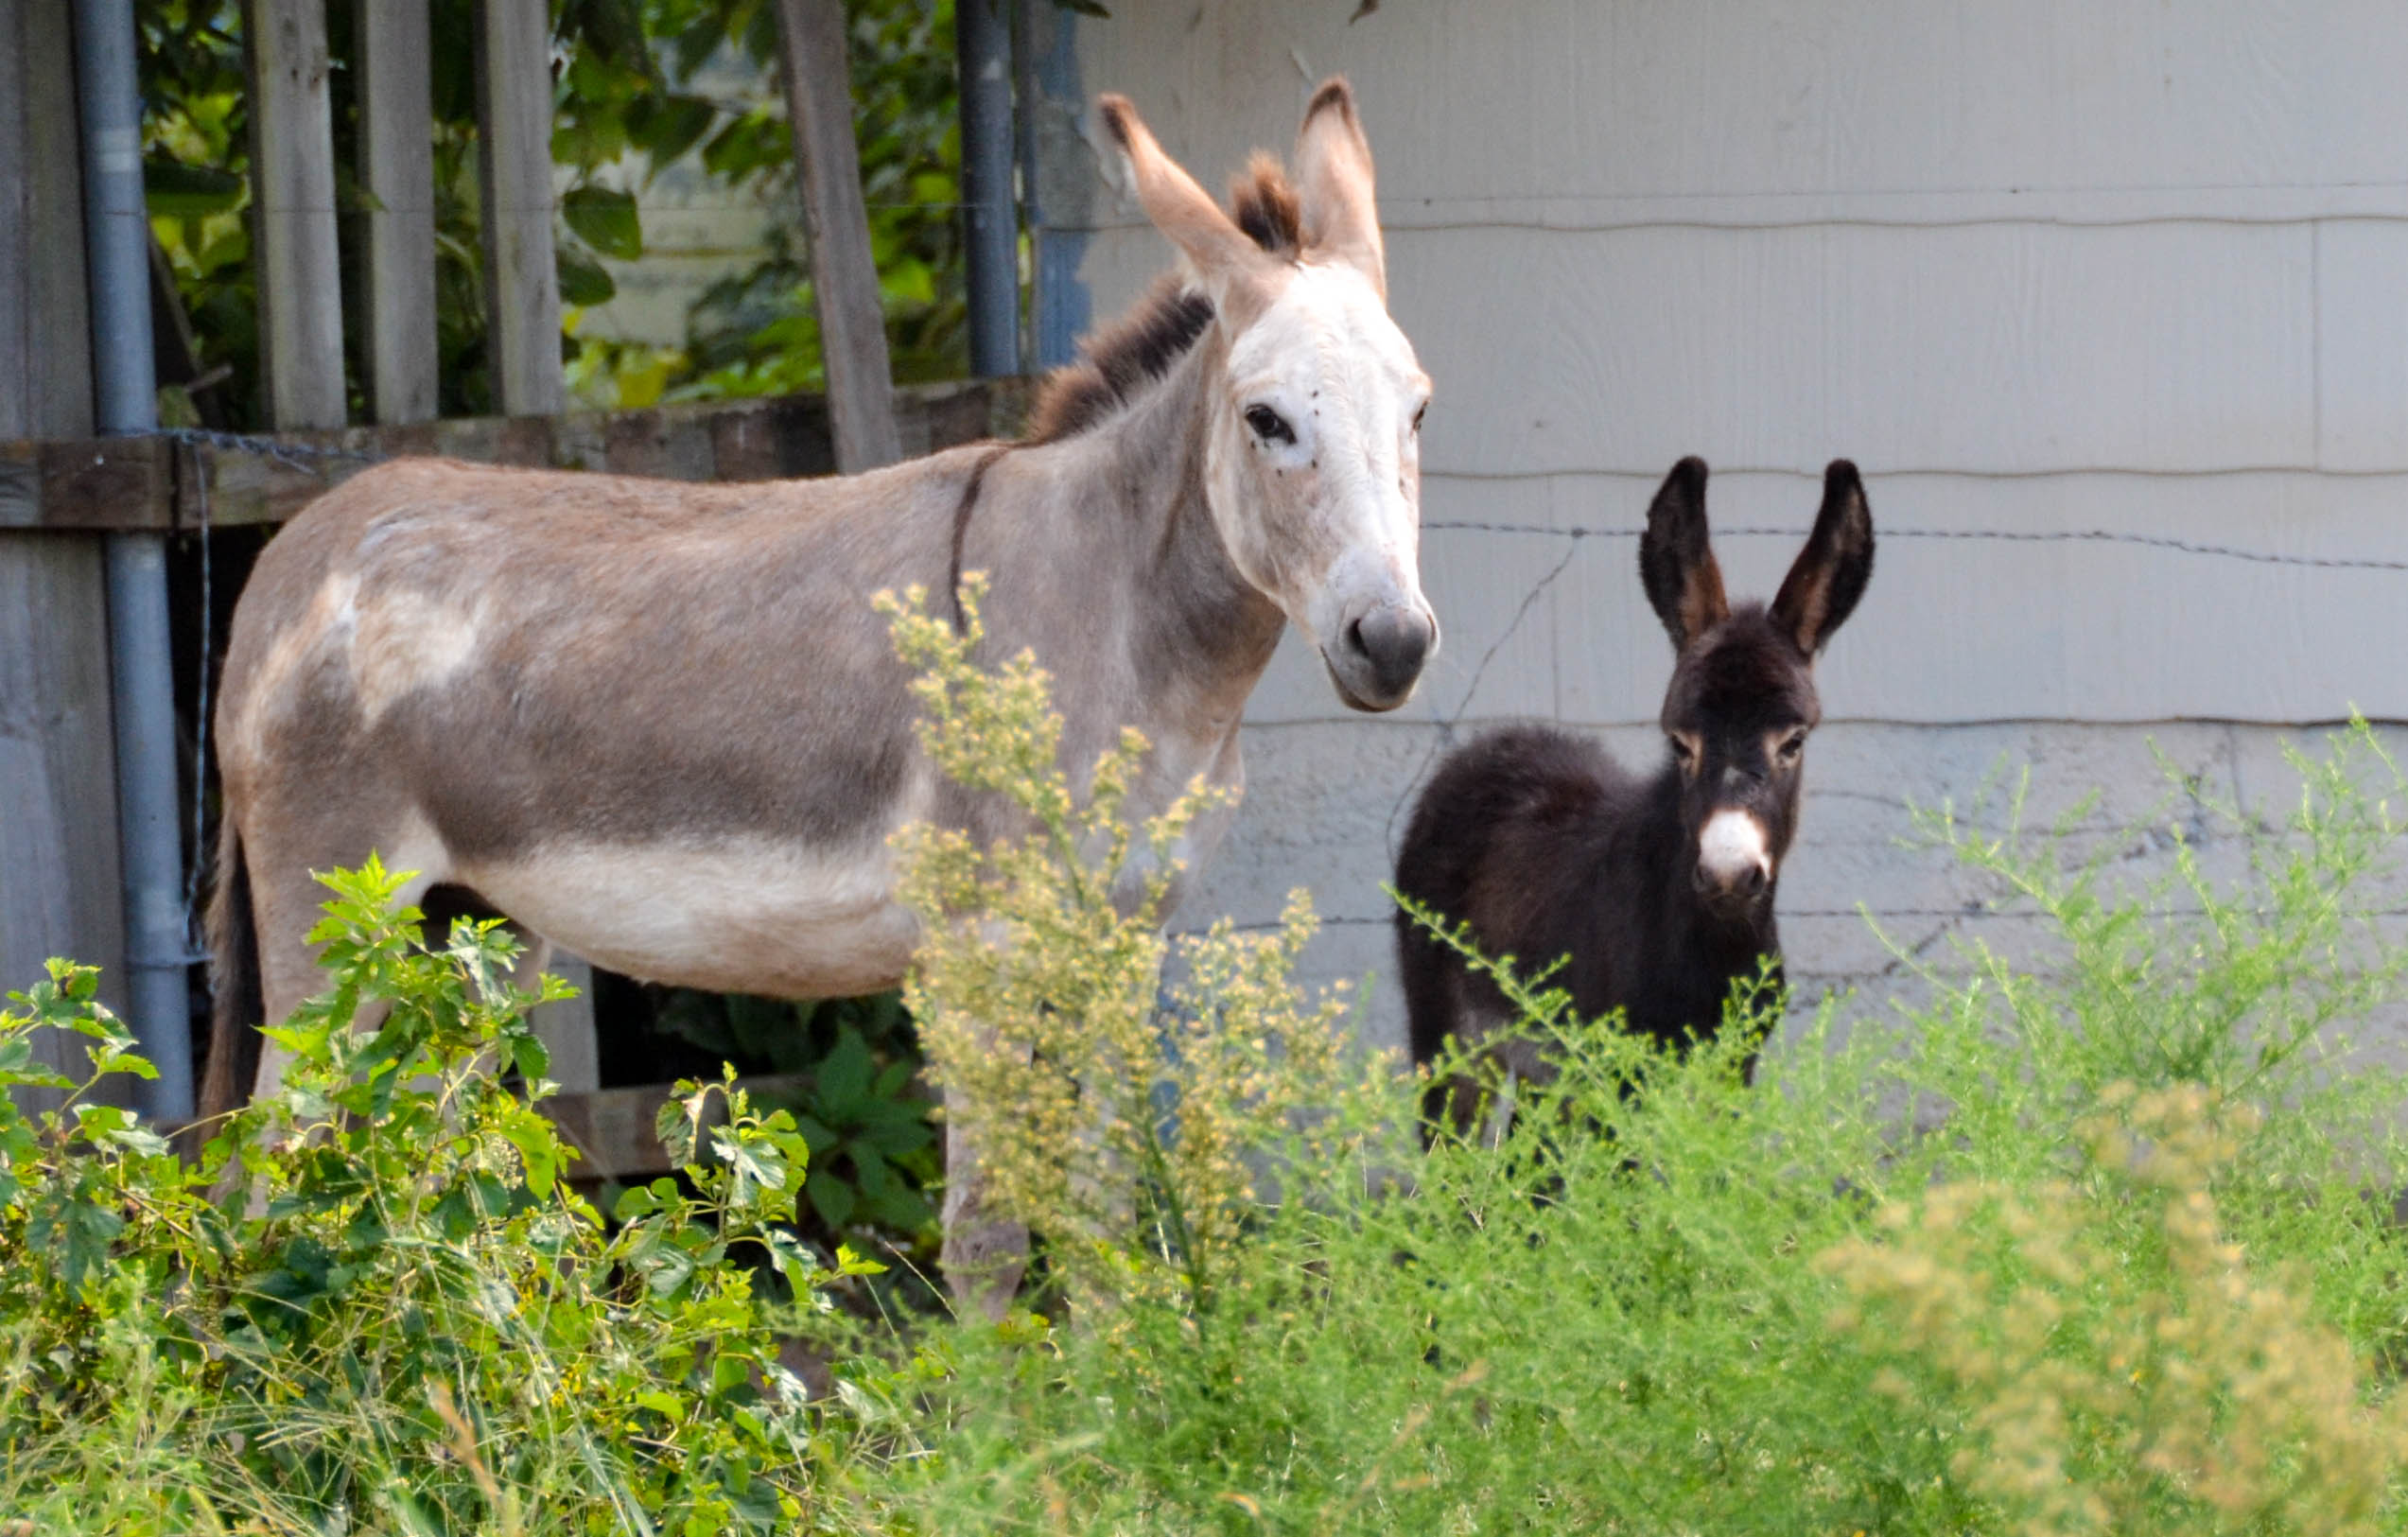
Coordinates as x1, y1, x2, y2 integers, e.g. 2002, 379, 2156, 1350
0, 863, 864, 1534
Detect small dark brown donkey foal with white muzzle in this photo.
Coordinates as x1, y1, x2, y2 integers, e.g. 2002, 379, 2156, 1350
1397, 458, 1874, 1130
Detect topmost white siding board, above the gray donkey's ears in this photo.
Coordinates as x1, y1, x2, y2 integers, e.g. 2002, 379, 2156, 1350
1079, 0, 2408, 200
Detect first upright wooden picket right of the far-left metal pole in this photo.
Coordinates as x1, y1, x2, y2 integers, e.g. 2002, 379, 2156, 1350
243, 0, 344, 428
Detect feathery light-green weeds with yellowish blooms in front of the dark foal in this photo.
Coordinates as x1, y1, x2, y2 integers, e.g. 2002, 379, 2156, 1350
852, 604, 2408, 1534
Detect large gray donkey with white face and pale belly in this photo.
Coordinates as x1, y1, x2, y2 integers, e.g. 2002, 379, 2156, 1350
204, 79, 1438, 1308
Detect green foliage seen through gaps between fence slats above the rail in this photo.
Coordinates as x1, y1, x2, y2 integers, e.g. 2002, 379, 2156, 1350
135, 0, 966, 427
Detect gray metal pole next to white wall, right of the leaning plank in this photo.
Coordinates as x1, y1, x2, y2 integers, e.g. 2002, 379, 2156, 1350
953, 0, 1021, 378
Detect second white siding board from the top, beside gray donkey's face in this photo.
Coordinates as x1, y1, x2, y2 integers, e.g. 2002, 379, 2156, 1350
1086, 224, 2312, 475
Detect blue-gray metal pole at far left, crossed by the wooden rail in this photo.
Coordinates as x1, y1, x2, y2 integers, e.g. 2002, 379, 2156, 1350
75, 0, 193, 1120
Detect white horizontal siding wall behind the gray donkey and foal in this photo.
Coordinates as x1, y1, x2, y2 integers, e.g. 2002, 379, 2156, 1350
1038, 0, 2408, 1055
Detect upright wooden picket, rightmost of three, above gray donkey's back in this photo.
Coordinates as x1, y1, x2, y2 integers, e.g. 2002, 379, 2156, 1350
477, 0, 568, 417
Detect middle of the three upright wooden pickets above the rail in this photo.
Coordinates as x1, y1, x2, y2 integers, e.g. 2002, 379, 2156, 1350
352, 0, 436, 422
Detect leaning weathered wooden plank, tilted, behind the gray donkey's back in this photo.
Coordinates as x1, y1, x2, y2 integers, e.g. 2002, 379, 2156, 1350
777, 0, 903, 475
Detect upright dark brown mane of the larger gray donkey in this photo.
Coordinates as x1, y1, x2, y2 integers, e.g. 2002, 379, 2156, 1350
1028, 151, 1302, 444
